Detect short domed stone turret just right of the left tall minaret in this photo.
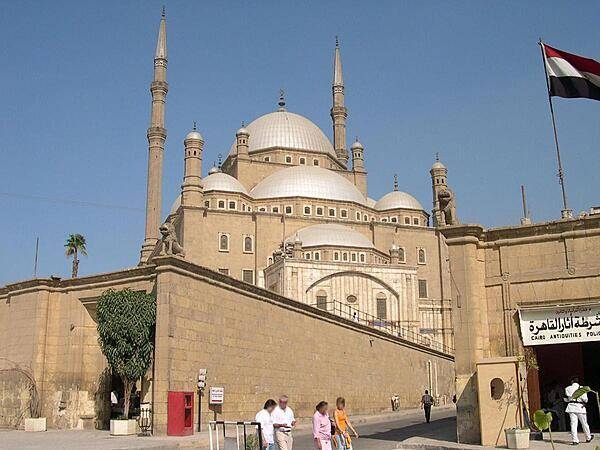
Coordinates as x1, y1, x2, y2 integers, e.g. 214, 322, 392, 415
181, 122, 204, 206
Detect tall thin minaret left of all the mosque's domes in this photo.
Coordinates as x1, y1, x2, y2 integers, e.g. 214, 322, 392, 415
140, 8, 169, 264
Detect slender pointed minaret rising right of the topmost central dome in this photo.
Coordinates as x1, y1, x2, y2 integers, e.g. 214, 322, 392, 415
331, 36, 348, 166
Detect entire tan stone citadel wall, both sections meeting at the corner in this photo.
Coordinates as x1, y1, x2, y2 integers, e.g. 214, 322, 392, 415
0, 257, 454, 434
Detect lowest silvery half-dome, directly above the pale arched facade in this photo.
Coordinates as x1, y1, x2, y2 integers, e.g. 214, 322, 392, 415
286, 223, 375, 248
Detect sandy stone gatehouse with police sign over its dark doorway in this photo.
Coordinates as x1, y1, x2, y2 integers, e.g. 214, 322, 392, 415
443, 214, 600, 445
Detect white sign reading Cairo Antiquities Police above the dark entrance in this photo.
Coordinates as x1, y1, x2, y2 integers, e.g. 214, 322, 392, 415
519, 304, 600, 345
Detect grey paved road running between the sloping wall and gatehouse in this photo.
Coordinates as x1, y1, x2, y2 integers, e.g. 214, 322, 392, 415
294, 410, 456, 450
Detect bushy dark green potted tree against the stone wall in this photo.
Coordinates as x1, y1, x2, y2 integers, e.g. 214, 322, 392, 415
97, 289, 156, 419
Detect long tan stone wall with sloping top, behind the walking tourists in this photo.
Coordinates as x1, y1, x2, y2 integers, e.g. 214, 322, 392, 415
153, 258, 454, 433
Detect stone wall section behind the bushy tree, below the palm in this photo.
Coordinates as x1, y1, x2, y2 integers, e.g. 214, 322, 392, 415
0, 268, 153, 428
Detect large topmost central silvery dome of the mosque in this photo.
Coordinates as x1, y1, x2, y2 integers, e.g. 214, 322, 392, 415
229, 111, 335, 158
